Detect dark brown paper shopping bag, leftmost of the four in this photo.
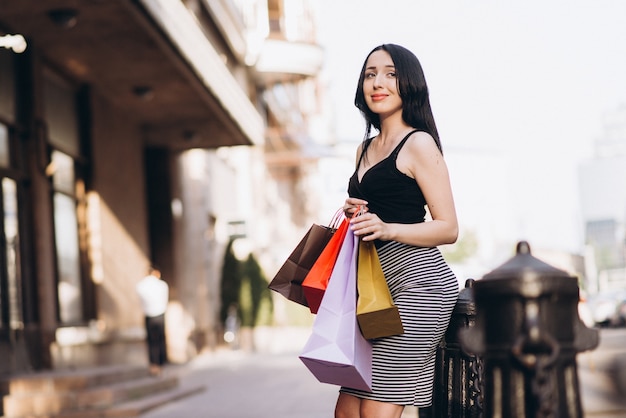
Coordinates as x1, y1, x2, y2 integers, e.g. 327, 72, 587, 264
268, 224, 335, 307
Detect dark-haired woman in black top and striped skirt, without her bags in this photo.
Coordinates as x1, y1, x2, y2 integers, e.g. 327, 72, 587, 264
335, 44, 459, 418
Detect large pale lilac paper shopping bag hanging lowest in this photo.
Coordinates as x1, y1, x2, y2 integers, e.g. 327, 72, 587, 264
300, 230, 372, 391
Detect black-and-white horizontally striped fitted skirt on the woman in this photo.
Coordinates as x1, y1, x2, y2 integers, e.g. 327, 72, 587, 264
341, 241, 459, 407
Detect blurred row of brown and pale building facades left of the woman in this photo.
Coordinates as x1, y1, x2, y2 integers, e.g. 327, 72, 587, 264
0, 0, 322, 374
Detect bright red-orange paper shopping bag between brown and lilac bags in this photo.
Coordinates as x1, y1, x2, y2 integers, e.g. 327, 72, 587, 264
302, 218, 349, 314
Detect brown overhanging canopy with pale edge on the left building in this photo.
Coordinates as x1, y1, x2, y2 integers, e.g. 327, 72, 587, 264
0, 0, 264, 149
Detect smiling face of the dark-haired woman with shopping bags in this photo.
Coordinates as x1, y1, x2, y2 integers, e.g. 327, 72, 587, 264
363, 50, 402, 117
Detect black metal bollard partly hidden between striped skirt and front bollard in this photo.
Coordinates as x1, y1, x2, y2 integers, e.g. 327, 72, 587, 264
419, 279, 482, 418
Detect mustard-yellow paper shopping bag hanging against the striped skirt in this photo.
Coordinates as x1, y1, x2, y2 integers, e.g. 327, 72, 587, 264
356, 240, 404, 339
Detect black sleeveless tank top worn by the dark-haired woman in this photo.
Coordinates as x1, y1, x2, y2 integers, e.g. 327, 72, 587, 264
348, 129, 426, 224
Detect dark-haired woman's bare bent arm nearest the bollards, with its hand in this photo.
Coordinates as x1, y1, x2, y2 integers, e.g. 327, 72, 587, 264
351, 132, 458, 247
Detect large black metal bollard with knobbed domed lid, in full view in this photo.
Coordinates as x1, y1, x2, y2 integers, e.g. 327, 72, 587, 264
460, 241, 598, 418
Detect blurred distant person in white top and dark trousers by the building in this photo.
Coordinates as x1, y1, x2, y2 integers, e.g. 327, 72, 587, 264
136, 268, 169, 376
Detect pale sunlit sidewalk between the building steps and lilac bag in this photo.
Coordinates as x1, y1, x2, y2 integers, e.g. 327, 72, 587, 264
141, 329, 417, 418
